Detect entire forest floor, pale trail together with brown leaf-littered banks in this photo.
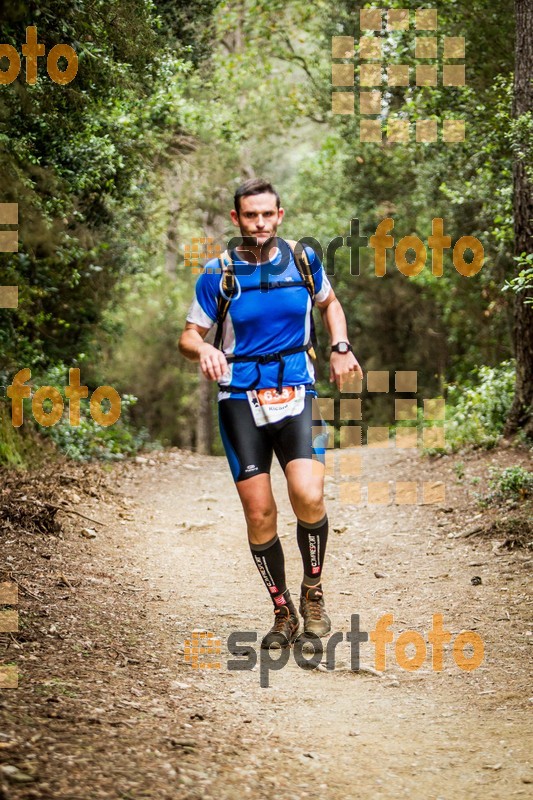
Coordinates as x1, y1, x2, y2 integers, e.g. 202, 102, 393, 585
0, 448, 533, 800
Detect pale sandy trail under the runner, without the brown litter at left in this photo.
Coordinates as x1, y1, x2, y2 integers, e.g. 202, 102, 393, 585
114, 448, 533, 800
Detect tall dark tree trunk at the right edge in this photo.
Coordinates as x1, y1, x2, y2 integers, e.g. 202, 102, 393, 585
505, 0, 533, 438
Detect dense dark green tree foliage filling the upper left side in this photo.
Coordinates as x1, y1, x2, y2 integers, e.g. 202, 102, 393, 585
0, 0, 204, 369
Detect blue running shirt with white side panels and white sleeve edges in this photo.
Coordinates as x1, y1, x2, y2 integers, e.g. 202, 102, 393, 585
187, 241, 331, 400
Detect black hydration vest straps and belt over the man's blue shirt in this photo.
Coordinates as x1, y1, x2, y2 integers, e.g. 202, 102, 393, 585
213, 240, 317, 393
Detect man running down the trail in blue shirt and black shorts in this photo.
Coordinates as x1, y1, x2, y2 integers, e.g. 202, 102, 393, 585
179, 178, 363, 648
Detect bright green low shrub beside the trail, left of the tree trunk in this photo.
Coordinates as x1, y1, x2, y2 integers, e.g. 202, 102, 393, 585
446, 360, 515, 451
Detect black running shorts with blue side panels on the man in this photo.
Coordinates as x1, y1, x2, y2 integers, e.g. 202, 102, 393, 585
218, 393, 328, 482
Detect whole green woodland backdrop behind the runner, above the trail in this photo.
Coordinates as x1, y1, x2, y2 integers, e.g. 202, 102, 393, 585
0, 0, 533, 466
